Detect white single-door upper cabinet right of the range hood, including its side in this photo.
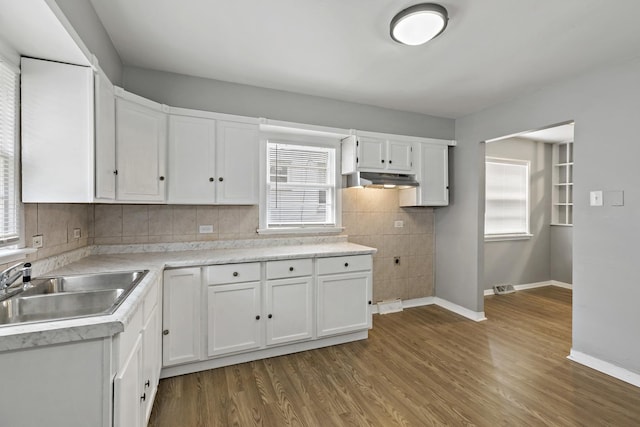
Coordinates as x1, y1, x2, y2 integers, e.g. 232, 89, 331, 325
399, 140, 450, 207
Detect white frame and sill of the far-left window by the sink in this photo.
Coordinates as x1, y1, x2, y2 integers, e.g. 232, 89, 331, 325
0, 55, 29, 263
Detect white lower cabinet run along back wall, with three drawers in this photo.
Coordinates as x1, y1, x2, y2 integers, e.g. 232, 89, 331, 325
162, 254, 372, 377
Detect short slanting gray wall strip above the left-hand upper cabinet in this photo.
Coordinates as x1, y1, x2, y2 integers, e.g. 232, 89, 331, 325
55, 0, 122, 85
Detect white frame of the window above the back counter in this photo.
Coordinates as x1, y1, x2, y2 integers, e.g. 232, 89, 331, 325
257, 134, 343, 235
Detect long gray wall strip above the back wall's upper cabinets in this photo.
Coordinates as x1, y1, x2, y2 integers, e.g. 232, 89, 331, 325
124, 67, 455, 139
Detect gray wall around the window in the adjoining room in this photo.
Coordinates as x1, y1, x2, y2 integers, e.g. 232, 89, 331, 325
483, 138, 552, 289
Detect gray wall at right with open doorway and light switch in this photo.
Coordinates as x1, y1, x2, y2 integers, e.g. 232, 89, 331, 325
436, 59, 640, 373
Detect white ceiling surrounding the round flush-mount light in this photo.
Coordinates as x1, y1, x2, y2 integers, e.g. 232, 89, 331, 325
91, 0, 640, 117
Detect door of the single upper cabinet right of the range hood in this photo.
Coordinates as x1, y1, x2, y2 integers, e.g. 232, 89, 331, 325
418, 144, 449, 206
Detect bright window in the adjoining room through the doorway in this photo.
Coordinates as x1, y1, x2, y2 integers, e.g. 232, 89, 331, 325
484, 157, 530, 240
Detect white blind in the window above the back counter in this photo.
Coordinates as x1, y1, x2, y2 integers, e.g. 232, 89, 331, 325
267, 142, 335, 227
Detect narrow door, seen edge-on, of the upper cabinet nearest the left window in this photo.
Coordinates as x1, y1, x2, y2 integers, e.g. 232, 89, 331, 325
95, 72, 116, 200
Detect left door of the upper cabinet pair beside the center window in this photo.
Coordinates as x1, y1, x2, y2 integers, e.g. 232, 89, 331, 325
168, 116, 217, 204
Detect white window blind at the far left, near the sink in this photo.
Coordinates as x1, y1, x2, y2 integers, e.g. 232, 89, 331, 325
0, 58, 20, 245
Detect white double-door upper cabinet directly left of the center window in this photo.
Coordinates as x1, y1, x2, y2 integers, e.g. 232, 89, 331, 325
169, 109, 259, 205
